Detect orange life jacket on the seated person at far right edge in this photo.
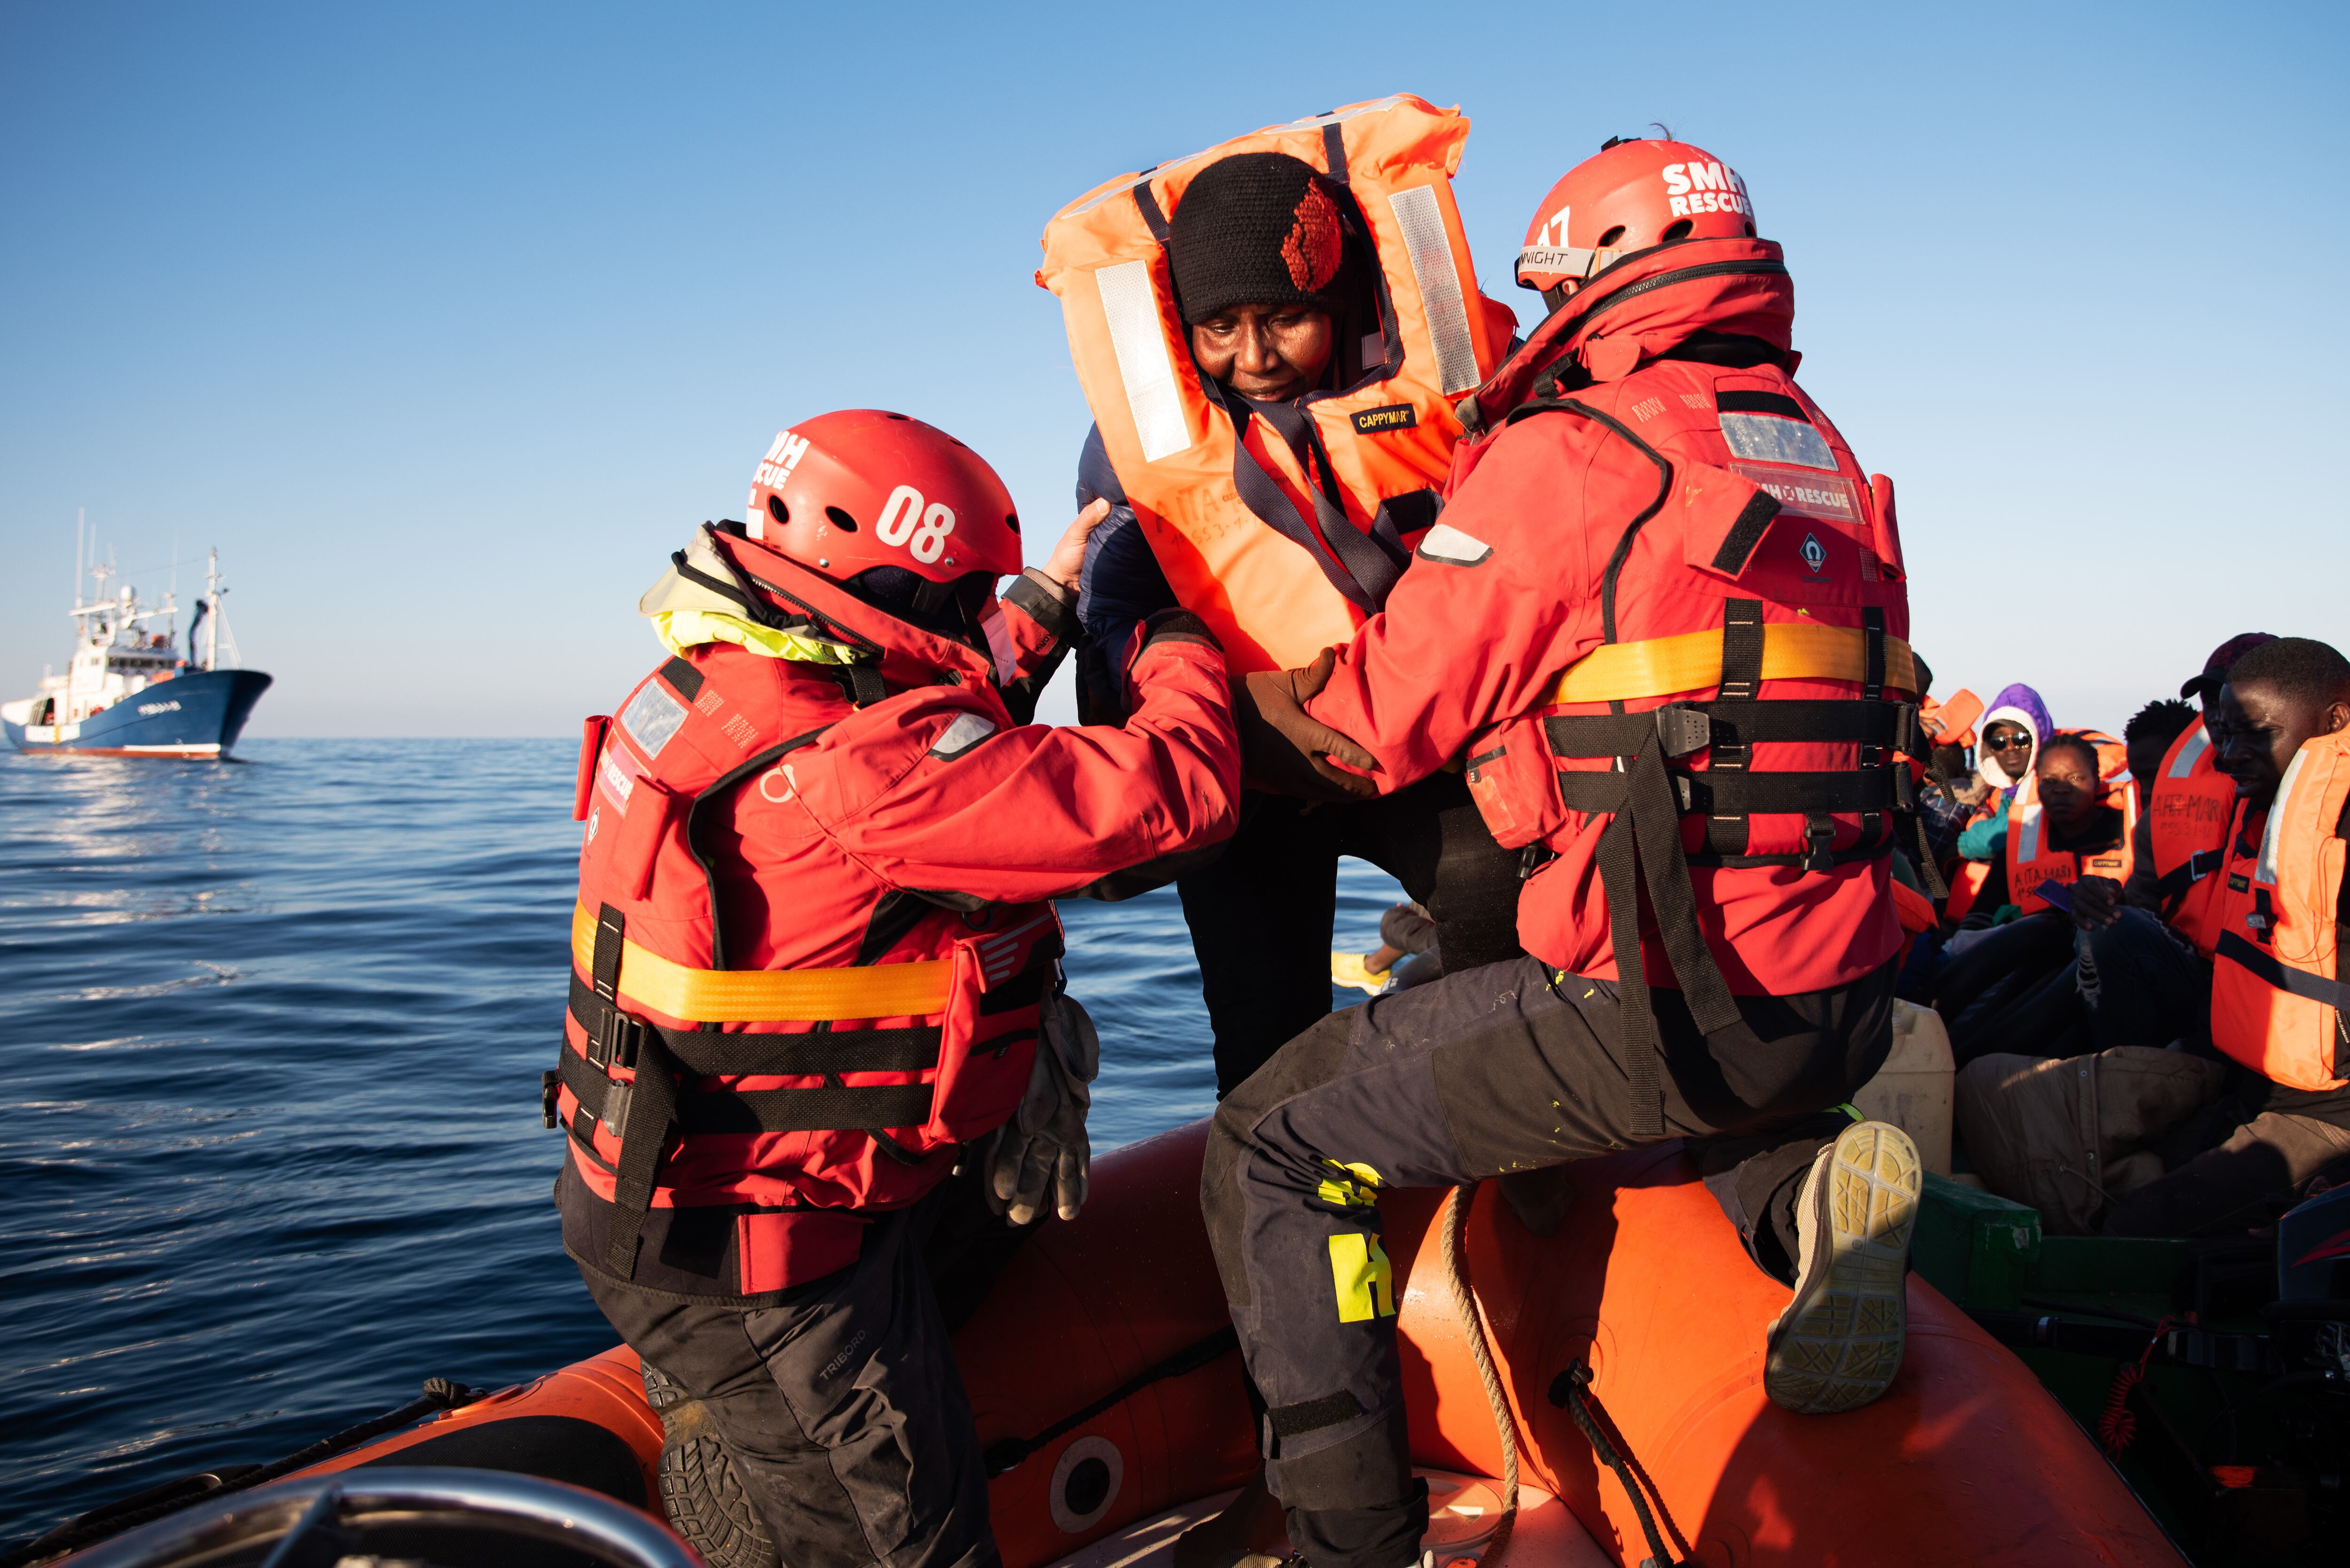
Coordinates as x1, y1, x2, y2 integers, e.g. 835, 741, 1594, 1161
2211, 731, 2350, 1088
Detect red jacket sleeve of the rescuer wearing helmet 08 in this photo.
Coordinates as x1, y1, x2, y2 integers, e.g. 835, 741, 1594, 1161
806, 640, 1241, 903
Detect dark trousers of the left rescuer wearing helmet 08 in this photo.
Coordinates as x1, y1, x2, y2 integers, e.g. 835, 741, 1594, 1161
580, 1183, 1006, 1568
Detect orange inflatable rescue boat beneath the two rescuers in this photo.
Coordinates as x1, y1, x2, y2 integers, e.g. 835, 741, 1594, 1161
19, 1123, 2186, 1568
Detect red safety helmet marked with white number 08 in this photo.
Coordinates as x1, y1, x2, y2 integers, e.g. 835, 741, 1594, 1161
743, 409, 1020, 588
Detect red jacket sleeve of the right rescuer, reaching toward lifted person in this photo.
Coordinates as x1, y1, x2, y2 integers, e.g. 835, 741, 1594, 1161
1307, 419, 1614, 790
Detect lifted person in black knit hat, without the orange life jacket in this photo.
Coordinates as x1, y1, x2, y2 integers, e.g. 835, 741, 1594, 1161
1076, 153, 1523, 1095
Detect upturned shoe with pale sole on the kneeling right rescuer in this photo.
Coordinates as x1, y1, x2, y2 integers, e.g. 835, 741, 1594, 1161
1762, 1121, 1925, 1415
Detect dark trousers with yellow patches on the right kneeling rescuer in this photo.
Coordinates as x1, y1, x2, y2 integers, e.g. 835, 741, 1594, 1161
1201, 957, 1894, 1568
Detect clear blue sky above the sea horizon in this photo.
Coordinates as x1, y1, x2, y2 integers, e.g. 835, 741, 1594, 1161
0, 0, 2350, 736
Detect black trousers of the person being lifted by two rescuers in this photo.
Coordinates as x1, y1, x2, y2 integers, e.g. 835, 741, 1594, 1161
1175, 773, 1523, 1095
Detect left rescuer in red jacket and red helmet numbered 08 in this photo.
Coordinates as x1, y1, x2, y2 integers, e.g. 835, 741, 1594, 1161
548, 412, 1241, 1568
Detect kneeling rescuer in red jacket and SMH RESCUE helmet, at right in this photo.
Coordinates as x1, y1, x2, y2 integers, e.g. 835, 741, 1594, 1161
1203, 141, 1925, 1568
